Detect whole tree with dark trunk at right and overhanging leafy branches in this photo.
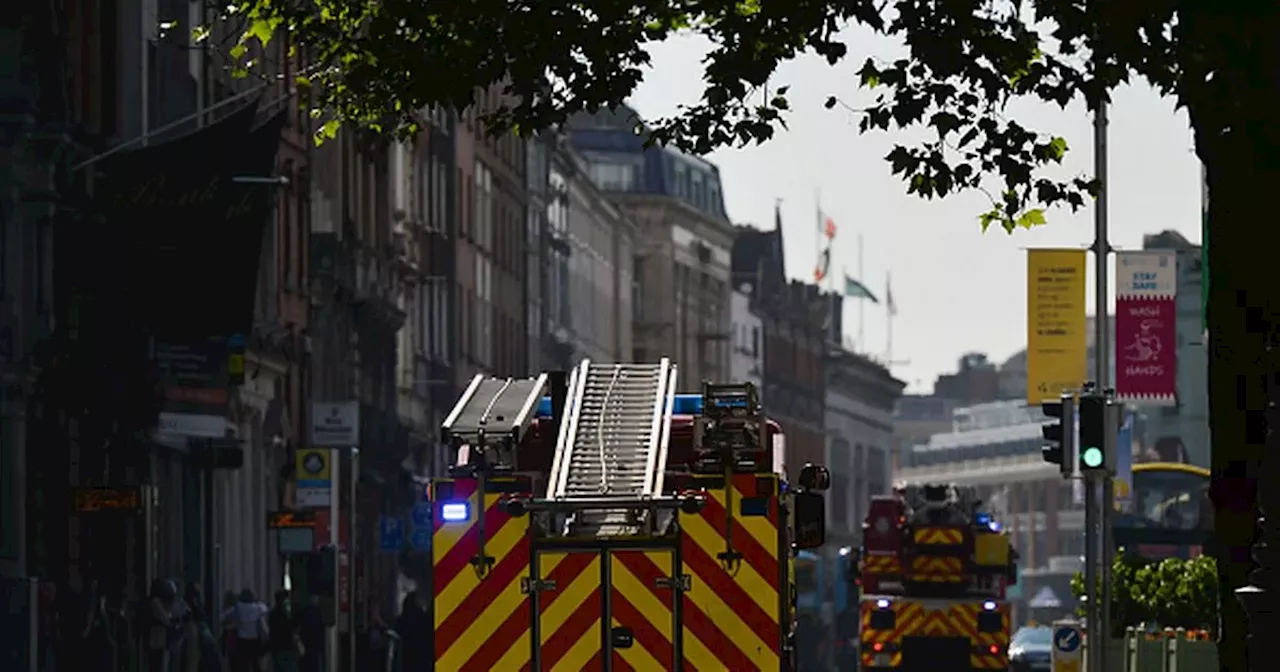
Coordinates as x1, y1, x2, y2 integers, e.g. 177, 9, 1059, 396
202, 0, 1280, 668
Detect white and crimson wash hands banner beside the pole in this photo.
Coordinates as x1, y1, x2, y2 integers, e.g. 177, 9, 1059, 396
1116, 250, 1178, 406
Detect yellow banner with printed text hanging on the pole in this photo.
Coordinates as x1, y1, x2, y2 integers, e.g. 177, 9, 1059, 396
1027, 250, 1088, 404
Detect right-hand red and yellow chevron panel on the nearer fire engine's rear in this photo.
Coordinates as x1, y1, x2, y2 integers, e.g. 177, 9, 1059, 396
680, 474, 781, 672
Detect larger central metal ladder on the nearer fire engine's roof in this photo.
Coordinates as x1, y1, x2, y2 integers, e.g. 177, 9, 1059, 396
547, 357, 676, 536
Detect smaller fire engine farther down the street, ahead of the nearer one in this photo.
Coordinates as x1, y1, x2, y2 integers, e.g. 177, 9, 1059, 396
859, 484, 1018, 672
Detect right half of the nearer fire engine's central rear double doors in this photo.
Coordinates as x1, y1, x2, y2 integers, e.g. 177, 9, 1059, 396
605, 549, 681, 672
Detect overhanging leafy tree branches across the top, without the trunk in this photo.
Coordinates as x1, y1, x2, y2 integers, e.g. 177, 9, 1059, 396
197, 0, 1249, 230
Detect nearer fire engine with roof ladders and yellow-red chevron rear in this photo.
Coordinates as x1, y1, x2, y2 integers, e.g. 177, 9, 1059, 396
419, 358, 829, 672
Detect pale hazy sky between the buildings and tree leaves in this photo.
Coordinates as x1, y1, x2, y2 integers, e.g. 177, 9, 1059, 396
631, 31, 1201, 392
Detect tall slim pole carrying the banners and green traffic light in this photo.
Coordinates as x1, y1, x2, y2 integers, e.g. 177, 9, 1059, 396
1084, 81, 1117, 672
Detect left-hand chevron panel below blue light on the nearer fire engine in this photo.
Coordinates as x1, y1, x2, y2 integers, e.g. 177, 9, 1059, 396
431, 479, 530, 672
